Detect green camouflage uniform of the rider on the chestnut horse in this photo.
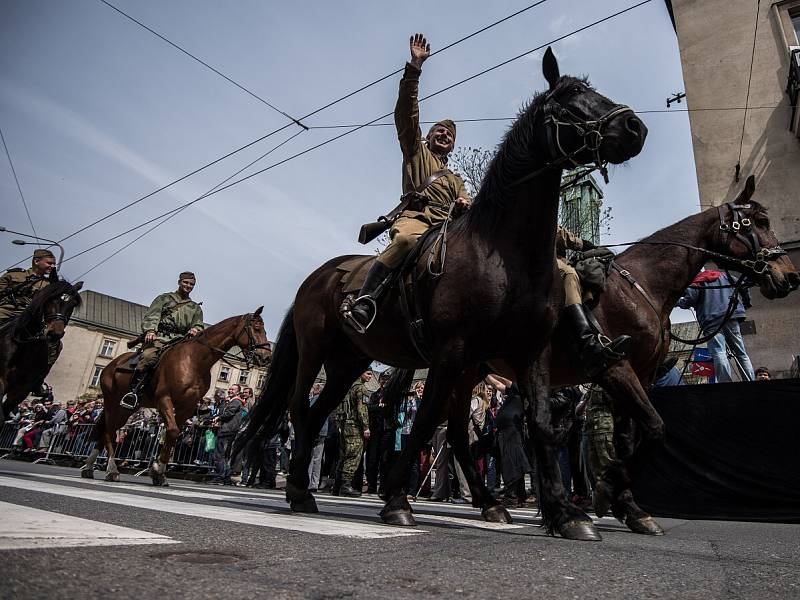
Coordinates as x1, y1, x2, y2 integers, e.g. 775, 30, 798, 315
137, 292, 204, 370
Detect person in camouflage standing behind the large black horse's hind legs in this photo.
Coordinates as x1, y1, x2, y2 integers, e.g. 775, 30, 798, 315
333, 371, 372, 497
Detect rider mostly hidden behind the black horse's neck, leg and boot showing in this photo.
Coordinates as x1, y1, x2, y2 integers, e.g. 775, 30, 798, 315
556, 227, 631, 377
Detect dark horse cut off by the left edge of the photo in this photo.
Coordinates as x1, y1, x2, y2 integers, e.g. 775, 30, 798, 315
0, 270, 83, 414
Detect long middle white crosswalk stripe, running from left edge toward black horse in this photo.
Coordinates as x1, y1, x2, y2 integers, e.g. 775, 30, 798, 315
0, 476, 423, 539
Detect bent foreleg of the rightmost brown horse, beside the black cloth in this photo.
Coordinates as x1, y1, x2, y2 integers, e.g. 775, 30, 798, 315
595, 361, 664, 535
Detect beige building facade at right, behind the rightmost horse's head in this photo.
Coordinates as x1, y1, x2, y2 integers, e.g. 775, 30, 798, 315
667, 0, 800, 377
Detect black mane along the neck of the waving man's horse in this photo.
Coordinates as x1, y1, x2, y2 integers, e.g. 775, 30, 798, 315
454, 75, 588, 235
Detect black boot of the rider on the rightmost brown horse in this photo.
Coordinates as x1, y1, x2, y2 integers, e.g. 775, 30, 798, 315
563, 304, 631, 377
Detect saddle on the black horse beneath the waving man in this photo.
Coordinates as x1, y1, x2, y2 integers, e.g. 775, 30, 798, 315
336, 223, 444, 362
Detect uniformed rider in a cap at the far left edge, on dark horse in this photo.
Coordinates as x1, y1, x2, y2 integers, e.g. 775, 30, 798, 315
0, 248, 61, 365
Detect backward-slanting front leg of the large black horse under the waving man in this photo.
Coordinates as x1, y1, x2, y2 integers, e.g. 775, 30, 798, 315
380, 352, 461, 525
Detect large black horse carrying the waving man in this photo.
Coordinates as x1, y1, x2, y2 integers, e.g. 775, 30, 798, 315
241, 50, 647, 538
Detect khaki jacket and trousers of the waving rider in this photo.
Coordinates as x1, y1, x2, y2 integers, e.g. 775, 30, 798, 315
378, 63, 469, 269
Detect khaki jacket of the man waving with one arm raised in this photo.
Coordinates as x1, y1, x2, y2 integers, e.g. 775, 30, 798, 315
394, 63, 469, 225
